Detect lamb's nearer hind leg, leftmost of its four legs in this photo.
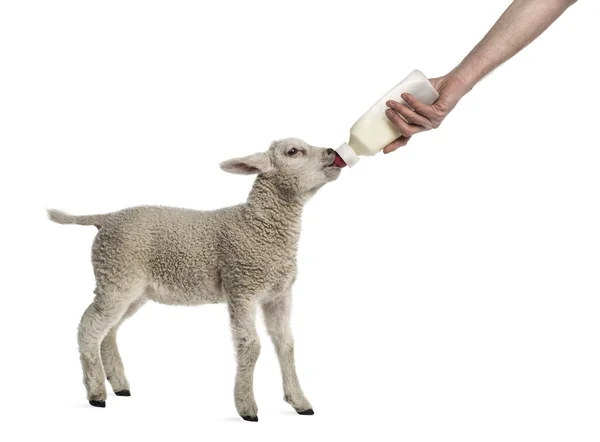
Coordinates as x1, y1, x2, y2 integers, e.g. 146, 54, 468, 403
77, 288, 141, 407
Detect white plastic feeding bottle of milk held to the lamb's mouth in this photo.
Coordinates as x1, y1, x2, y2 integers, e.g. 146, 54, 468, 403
336, 70, 439, 167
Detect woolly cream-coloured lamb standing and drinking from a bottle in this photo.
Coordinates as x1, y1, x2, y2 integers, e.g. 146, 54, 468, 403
48, 138, 340, 422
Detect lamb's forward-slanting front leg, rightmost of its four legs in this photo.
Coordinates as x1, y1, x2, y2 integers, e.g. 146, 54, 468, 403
262, 292, 314, 415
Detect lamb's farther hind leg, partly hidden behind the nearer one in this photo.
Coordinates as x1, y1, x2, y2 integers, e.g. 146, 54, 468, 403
100, 295, 148, 396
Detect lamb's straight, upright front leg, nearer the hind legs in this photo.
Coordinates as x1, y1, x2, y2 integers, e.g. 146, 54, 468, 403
228, 297, 260, 422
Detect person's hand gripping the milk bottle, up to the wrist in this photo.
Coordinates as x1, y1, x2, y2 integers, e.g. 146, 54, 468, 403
383, 74, 470, 153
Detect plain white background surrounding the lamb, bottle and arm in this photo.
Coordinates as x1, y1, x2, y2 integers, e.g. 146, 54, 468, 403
0, 0, 600, 442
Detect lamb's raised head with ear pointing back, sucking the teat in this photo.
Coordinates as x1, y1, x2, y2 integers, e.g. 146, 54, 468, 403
221, 138, 341, 199
